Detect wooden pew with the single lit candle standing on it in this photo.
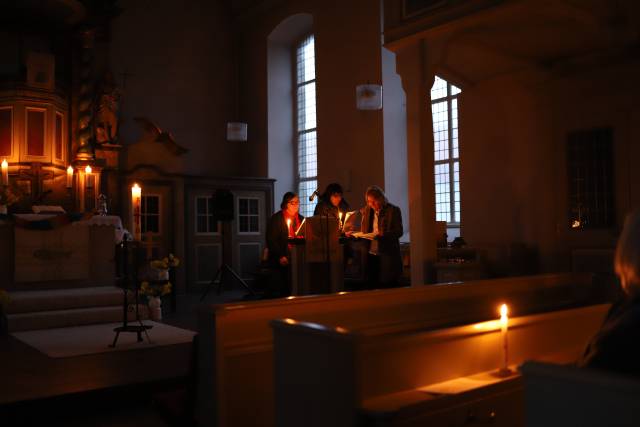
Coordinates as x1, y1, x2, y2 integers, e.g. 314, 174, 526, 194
272, 304, 609, 427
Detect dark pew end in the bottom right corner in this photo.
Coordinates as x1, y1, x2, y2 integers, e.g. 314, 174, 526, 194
522, 362, 640, 427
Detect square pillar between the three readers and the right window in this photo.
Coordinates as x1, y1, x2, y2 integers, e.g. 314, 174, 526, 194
393, 40, 436, 286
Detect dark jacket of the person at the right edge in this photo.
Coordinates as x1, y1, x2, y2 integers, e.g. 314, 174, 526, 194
578, 295, 640, 376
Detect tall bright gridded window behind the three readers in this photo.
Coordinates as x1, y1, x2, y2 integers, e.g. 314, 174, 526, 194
295, 35, 318, 216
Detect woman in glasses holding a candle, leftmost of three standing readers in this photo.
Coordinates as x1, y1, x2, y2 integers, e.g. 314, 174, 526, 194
267, 192, 303, 297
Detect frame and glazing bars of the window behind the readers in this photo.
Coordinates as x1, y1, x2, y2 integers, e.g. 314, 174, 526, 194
292, 32, 318, 216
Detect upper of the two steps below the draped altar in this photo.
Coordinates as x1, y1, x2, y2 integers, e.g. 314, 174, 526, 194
7, 286, 134, 314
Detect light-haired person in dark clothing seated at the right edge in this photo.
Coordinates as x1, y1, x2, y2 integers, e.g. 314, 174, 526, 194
578, 211, 640, 376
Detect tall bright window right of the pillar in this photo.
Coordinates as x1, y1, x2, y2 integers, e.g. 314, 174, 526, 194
431, 76, 461, 236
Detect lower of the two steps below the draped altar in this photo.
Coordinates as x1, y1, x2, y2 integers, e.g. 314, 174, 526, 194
7, 304, 148, 332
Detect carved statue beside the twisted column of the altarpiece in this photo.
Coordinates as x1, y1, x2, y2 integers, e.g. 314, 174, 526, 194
95, 71, 122, 144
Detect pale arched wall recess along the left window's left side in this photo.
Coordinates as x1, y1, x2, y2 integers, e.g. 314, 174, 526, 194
267, 13, 313, 206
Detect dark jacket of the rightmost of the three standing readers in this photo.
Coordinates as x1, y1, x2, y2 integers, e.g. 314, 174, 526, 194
360, 203, 403, 283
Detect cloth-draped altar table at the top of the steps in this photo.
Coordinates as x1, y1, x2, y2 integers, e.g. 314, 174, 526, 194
0, 214, 124, 290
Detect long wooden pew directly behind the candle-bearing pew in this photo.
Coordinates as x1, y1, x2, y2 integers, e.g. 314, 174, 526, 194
197, 273, 601, 427
